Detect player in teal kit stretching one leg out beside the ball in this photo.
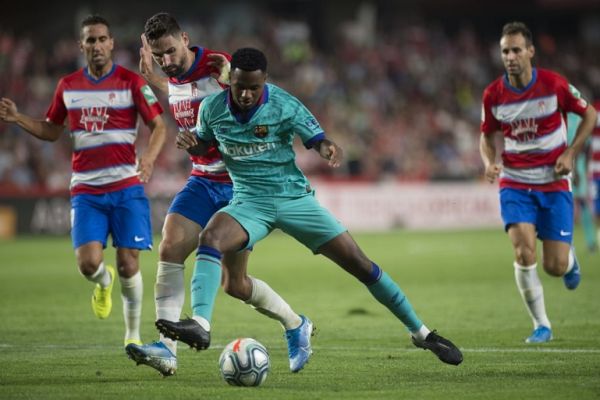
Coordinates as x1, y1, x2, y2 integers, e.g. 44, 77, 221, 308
163, 48, 463, 365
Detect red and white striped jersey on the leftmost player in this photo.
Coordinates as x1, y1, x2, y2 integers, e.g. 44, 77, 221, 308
46, 64, 163, 195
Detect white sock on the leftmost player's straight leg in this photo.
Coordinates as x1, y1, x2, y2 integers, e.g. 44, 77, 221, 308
119, 271, 144, 340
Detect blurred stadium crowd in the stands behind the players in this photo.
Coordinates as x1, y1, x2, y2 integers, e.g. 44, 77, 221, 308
0, 0, 600, 194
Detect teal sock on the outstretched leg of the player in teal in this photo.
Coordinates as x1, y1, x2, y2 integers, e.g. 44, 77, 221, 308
367, 271, 423, 332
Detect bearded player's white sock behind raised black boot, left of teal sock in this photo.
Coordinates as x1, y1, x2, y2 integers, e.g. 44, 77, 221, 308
154, 261, 185, 354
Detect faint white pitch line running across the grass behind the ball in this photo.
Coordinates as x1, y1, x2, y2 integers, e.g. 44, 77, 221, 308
0, 343, 600, 354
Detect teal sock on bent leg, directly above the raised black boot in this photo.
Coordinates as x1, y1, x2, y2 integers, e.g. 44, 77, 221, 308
192, 246, 221, 322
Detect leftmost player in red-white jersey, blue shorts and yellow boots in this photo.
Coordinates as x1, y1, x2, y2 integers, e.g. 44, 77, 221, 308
0, 15, 165, 346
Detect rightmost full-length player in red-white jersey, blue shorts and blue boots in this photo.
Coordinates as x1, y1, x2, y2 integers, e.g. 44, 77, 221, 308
480, 22, 596, 343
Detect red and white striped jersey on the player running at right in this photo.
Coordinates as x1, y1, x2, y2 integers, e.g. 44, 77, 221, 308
481, 68, 587, 191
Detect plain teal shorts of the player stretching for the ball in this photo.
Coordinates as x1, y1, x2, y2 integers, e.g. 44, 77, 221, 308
219, 192, 346, 253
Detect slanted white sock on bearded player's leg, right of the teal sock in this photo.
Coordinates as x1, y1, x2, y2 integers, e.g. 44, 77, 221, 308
245, 276, 302, 330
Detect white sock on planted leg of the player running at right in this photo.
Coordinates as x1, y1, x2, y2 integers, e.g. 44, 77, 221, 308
514, 261, 551, 328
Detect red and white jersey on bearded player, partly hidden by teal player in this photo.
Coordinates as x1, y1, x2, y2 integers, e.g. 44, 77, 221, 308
169, 47, 231, 182
